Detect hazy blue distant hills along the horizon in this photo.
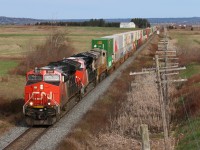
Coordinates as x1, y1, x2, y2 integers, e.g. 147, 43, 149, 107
0, 16, 200, 25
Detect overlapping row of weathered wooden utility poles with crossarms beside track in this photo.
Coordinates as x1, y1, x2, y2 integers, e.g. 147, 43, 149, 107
130, 28, 187, 150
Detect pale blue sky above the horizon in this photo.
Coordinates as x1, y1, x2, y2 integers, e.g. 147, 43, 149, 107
0, 0, 200, 19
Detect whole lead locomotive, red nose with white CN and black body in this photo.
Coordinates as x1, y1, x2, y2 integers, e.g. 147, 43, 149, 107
23, 60, 81, 125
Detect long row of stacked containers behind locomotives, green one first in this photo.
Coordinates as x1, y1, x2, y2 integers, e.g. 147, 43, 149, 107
92, 27, 156, 68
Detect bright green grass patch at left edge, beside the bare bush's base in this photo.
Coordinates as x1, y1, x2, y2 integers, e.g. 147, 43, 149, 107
0, 60, 18, 76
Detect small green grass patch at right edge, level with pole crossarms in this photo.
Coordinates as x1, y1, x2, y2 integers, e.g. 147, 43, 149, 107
180, 63, 200, 78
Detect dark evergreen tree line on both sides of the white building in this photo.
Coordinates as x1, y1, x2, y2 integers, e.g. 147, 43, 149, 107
35, 18, 150, 28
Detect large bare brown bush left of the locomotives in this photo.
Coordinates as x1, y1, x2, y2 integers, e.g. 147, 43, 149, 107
15, 31, 74, 75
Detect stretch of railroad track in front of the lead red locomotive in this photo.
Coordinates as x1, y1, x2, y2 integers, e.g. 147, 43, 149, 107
4, 127, 49, 150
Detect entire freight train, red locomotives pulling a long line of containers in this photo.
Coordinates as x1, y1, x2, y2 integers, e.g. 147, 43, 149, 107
23, 27, 156, 125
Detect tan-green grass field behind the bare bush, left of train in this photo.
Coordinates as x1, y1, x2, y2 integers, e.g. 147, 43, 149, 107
0, 26, 134, 58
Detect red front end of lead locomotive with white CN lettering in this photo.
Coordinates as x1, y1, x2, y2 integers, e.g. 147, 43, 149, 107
23, 68, 62, 125
